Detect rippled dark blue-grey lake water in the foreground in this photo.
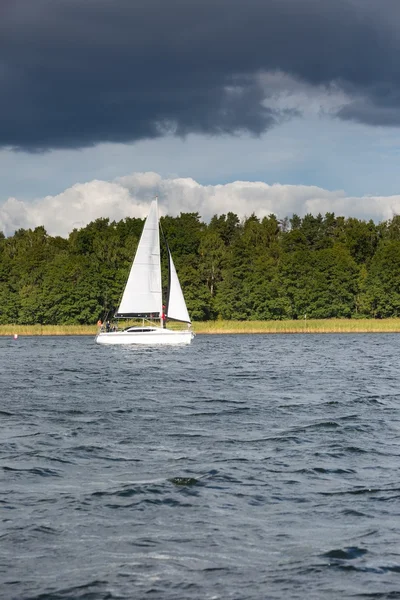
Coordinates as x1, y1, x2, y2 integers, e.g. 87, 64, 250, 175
0, 334, 400, 600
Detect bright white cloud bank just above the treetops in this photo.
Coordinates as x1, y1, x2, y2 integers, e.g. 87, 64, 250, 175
0, 172, 400, 236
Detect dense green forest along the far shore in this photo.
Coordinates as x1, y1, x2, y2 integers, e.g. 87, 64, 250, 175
0, 212, 400, 324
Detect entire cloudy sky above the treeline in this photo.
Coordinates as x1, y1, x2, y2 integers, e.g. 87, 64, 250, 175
0, 0, 400, 236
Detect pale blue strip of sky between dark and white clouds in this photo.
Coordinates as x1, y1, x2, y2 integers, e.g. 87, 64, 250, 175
0, 117, 400, 201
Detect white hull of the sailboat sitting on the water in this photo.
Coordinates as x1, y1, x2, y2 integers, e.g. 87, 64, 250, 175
96, 327, 194, 346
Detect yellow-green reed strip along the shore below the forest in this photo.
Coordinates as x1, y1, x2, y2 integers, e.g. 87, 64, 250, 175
0, 318, 400, 336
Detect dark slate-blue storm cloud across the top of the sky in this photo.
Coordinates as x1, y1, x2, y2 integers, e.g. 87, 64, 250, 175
0, 0, 400, 151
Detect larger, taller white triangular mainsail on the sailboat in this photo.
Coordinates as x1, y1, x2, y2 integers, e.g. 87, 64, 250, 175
116, 200, 162, 317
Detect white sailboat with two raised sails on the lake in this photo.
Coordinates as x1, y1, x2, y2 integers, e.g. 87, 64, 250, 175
96, 199, 194, 346
